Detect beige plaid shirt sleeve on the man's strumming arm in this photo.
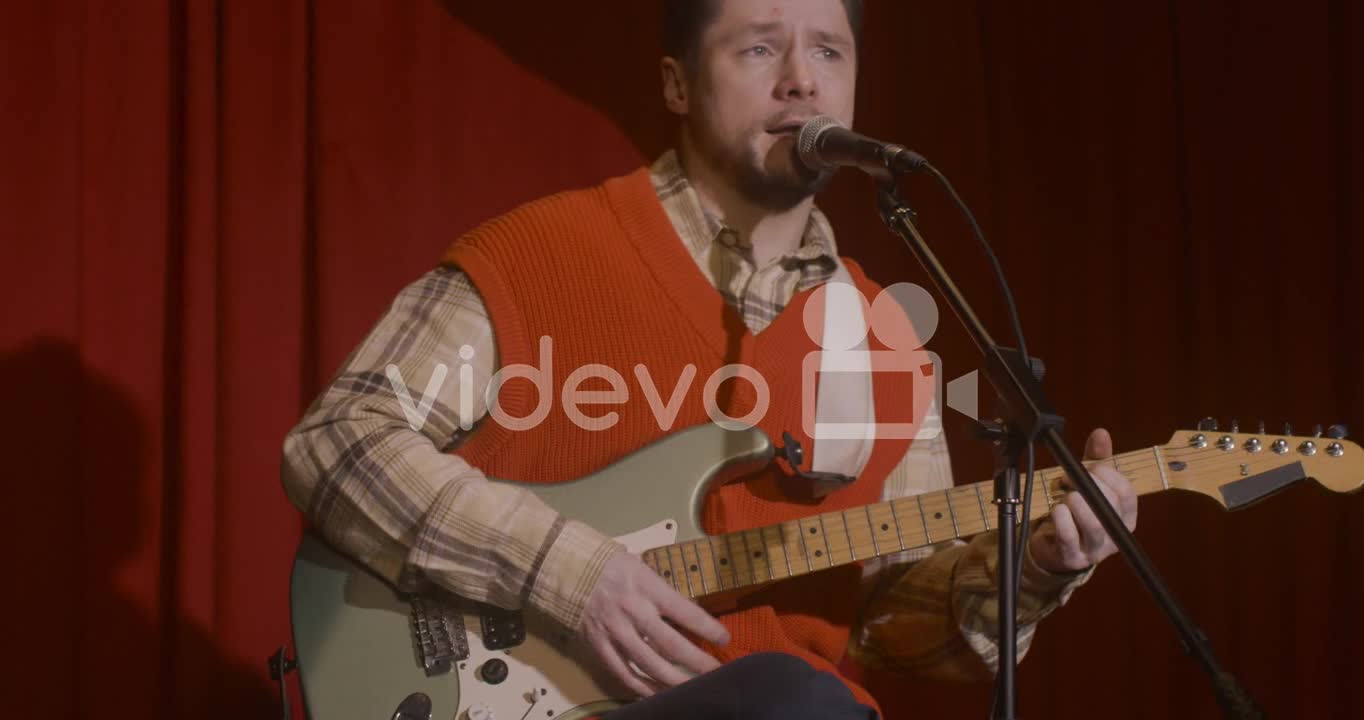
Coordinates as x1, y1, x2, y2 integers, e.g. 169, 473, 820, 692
282, 267, 621, 631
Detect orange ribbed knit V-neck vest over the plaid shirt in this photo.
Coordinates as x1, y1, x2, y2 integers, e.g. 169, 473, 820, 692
445, 169, 926, 706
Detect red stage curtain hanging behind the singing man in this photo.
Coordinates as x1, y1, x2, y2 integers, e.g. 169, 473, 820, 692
0, 0, 1364, 719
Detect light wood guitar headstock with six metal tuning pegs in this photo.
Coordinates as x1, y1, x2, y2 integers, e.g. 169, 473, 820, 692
1161, 419, 1364, 509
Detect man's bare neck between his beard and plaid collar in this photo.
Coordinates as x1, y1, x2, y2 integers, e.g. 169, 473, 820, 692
678, 132, 814, 267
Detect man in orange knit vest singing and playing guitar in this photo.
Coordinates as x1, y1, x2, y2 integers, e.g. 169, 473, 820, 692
284, 0, 1136, 720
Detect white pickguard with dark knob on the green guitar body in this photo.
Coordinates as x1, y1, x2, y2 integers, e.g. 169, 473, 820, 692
452, 520, 678, 720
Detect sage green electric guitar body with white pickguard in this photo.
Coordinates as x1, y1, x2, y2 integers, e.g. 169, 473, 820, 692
291, 424, 773, 720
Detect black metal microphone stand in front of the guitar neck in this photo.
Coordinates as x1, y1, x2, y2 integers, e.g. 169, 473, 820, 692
872, 181, 1264, 720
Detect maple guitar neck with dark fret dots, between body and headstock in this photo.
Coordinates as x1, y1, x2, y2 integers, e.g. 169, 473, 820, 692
642, 447, 1169, 597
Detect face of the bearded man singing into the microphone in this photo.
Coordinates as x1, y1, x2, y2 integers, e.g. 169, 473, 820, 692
686, 0, 857, 210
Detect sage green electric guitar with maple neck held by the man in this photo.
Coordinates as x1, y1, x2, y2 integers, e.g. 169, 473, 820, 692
291, 425, 1364, 720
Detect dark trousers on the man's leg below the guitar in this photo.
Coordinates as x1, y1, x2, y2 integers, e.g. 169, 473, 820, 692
602, 653, 878, 720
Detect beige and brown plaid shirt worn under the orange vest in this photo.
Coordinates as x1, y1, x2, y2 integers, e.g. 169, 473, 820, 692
282, 151, 1088, 676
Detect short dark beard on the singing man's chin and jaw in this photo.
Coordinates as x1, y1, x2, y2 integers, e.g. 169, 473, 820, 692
697, 118, 833, 213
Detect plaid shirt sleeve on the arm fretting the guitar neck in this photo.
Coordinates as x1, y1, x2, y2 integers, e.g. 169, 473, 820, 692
848, 432, 1093, 680
